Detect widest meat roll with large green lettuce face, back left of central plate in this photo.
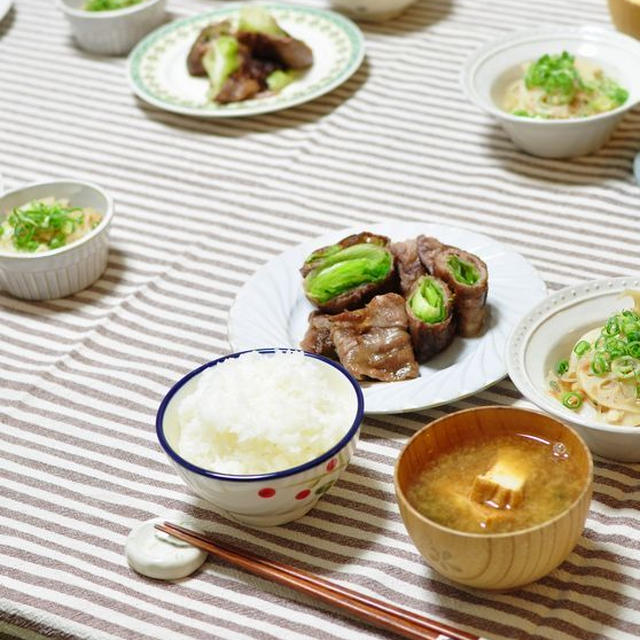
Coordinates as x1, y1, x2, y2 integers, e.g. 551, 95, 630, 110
300, 233, 396, 313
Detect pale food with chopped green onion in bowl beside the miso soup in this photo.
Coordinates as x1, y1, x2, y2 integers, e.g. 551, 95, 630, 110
548, 291, 640, 427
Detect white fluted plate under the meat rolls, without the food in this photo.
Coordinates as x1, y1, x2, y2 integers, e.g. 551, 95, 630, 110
228, 222, 546, 414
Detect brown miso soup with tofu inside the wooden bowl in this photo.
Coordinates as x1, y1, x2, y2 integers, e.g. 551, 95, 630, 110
407, 434, 584, 533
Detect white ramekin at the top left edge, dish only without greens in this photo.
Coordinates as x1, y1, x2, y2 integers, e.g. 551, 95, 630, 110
58, 0, 167, 56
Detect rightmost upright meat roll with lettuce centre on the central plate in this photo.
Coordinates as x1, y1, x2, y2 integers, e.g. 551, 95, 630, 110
433, 247, 489, 337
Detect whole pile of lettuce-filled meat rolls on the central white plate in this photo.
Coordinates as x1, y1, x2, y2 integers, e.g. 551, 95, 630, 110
300, 231, 488, 382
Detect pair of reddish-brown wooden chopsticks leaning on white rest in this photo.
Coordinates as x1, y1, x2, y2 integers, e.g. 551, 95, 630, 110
155, 522, 481, 640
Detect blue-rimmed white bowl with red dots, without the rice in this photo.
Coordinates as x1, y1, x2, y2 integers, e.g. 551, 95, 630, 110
156, 349, 364, 527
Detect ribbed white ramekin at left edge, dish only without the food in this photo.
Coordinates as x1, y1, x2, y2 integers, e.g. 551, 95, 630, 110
0, 180, 113, 300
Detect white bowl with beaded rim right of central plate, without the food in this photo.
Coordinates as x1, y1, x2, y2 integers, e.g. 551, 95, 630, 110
507, 277, 640, 462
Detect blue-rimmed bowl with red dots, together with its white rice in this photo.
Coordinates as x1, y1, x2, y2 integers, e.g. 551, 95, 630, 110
156, 349, 364, 527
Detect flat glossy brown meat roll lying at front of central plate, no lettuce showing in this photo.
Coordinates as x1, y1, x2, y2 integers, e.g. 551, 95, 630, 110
331, 293, 419, 382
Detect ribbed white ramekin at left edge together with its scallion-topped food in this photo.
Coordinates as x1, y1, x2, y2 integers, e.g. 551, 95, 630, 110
0, 179, 113, 300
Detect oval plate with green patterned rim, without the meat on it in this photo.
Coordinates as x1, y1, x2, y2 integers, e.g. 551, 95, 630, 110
128, 3, 364, 118
